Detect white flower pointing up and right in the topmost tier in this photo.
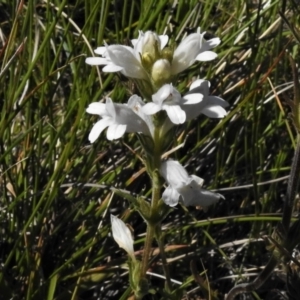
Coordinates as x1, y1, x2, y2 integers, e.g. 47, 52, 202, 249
172, 28, 221, 74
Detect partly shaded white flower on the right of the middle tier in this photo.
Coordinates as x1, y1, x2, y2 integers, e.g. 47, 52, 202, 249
181, 79, 229, 121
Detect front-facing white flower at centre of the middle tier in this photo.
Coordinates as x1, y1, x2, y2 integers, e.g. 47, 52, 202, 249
142, 84, 202, 124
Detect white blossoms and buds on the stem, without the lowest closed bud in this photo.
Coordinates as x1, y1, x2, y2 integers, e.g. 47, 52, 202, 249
86, 29, 228, 209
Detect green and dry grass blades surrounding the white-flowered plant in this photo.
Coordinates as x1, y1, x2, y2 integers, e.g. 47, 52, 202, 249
0, 0, 300, 300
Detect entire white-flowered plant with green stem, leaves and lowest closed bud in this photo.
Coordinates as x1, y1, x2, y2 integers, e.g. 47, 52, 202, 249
86, 30, 228, 299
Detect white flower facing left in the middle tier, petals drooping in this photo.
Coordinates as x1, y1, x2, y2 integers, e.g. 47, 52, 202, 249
86, 98, 150, 143
